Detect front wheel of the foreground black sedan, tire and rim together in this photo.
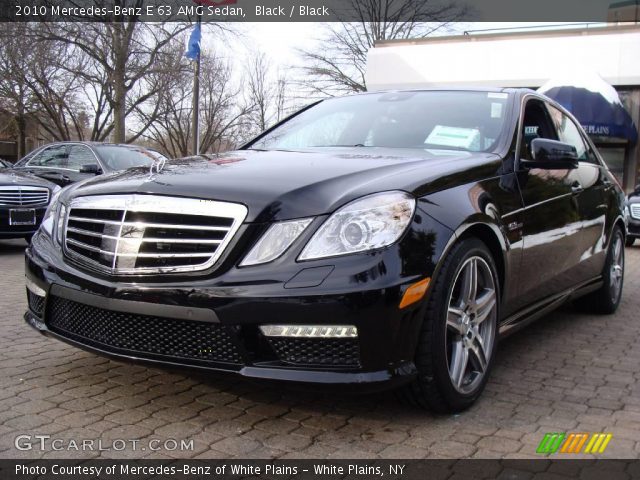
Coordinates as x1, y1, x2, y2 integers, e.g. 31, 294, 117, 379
399, 238, 500, 413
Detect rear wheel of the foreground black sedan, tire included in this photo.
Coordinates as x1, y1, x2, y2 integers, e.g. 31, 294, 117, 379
578, 228, 624, 315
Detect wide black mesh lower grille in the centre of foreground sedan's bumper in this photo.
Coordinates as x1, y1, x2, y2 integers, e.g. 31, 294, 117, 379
47, 296, 242, 364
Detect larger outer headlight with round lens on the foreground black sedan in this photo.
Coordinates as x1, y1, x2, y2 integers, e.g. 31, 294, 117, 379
299, 192, 416, 260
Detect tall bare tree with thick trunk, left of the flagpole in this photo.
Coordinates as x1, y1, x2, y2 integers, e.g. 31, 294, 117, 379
40, 9, 189, 143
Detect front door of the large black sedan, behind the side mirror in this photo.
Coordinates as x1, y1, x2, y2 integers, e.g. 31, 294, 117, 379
515, 97, 582, 308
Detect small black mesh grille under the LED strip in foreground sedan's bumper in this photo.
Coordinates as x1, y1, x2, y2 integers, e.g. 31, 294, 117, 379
267, 337, 360, 367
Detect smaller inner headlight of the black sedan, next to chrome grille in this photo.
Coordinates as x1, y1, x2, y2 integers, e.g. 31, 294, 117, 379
240, 218, 313, 267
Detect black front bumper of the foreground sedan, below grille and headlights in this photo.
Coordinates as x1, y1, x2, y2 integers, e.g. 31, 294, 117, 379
25, 227, 444, 389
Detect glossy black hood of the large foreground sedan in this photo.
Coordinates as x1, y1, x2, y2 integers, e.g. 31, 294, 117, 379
66, 147, 501, 222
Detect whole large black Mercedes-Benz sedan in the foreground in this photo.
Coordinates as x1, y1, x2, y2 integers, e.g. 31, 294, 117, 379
25, 89, 625, 411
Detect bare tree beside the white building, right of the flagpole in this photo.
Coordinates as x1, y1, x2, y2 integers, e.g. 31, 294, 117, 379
300, 0, 467, 96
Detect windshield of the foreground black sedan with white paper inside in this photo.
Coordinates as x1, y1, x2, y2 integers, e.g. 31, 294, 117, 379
249, 91, 508, 152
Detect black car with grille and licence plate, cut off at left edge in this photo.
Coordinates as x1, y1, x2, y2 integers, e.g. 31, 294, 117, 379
0, 169, 60, 241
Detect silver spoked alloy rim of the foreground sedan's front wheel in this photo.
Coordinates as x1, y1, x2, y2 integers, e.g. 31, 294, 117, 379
446, 256, 497, 394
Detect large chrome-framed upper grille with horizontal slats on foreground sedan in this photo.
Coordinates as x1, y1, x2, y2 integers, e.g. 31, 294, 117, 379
65, 195, 247, 274
